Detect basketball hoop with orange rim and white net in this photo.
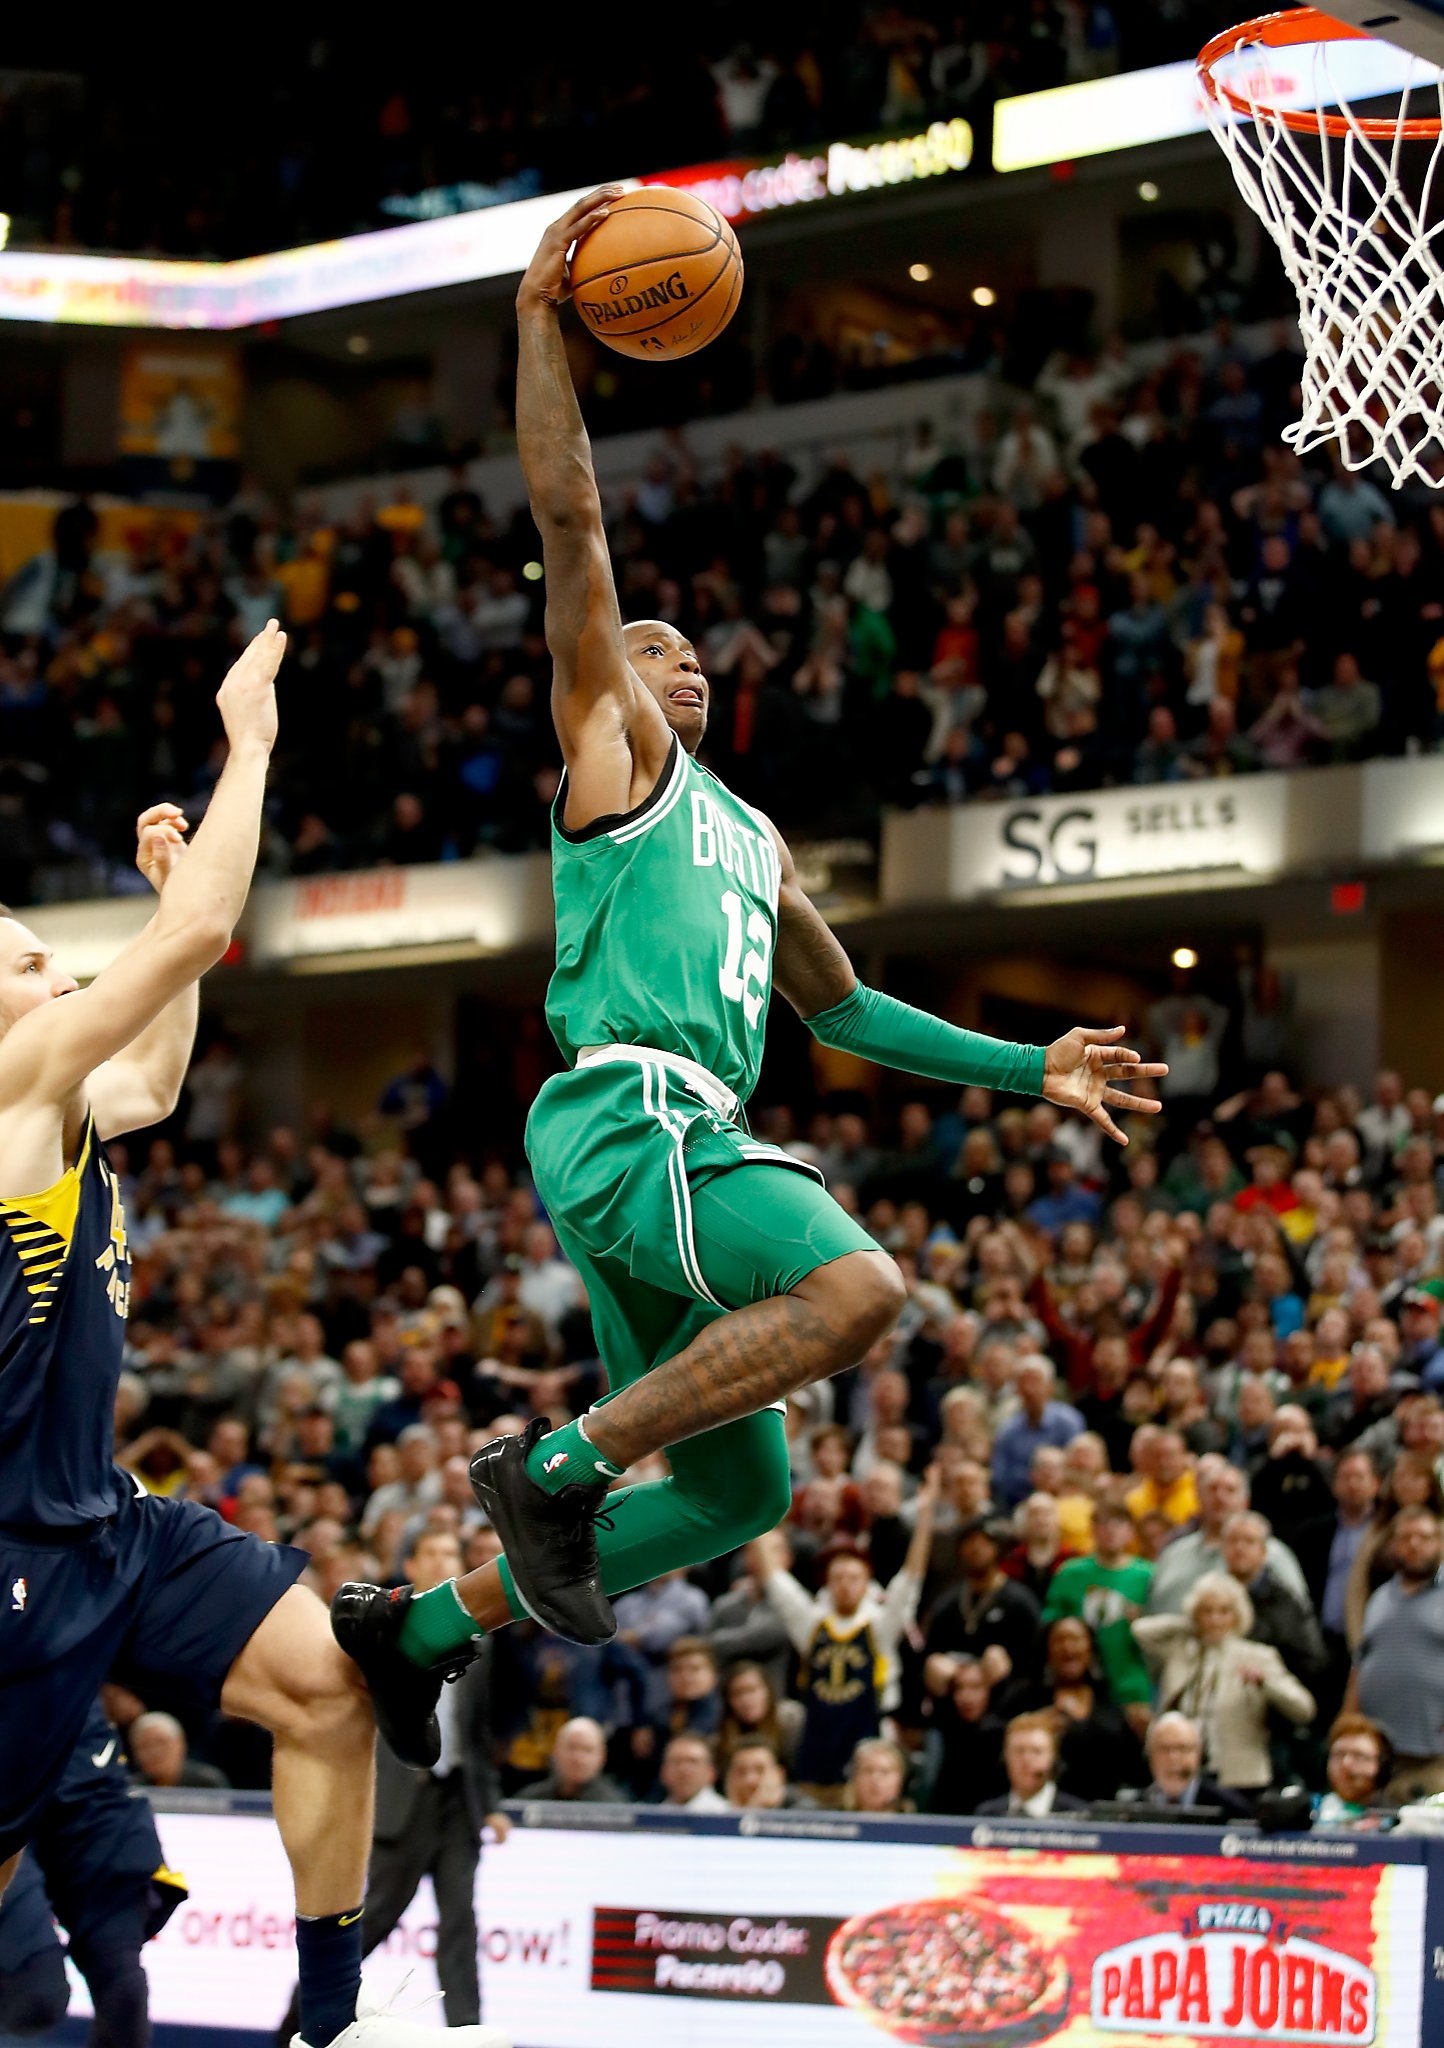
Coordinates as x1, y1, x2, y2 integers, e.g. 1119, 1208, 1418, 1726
1198, 6, 1444, 489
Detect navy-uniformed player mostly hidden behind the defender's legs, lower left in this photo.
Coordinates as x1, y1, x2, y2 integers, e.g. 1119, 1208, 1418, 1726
0, 1704, 186, 2048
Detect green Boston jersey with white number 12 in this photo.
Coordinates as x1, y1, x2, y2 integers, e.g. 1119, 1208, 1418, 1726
547, 737, 780, 1102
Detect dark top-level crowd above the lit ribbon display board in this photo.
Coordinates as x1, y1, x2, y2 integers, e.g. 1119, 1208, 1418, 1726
0, 0, 1217, 256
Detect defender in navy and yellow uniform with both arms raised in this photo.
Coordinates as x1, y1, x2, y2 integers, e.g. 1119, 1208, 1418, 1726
0, 621, 502, 2048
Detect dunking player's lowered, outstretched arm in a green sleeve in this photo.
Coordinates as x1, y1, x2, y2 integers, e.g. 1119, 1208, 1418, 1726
772, 827, 1167, 1145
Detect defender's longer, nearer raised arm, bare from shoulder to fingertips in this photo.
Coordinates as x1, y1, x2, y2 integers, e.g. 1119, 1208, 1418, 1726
0, 618, 285, 1114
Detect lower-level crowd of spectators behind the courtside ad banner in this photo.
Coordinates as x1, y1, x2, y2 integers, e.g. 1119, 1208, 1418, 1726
98, 1019, 1444, 1825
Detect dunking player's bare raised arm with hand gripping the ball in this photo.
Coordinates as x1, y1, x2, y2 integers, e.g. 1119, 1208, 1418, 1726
516, 186, 668, 827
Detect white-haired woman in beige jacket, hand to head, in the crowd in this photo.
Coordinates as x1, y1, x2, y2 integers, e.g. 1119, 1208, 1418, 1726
1133, 1571, 1317, 1792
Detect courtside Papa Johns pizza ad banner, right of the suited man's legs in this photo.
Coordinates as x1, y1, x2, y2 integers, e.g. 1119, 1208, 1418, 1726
485, 1829, 1426, 2048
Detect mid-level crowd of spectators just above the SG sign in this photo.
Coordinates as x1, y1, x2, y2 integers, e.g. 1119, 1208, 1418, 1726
0, 319, 1444, 901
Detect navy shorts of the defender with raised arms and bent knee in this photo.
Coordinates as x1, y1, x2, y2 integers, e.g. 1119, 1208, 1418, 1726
0, 1495, 309, 1862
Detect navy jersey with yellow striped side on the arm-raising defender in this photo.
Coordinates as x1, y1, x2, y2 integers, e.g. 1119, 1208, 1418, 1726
0, 1118, 135, 1528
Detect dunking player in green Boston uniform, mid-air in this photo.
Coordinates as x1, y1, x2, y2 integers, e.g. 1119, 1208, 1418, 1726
332, 186, 1165, 1755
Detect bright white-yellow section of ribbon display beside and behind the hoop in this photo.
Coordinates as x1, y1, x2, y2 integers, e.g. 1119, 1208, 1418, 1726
993, 41, 1417, 170
